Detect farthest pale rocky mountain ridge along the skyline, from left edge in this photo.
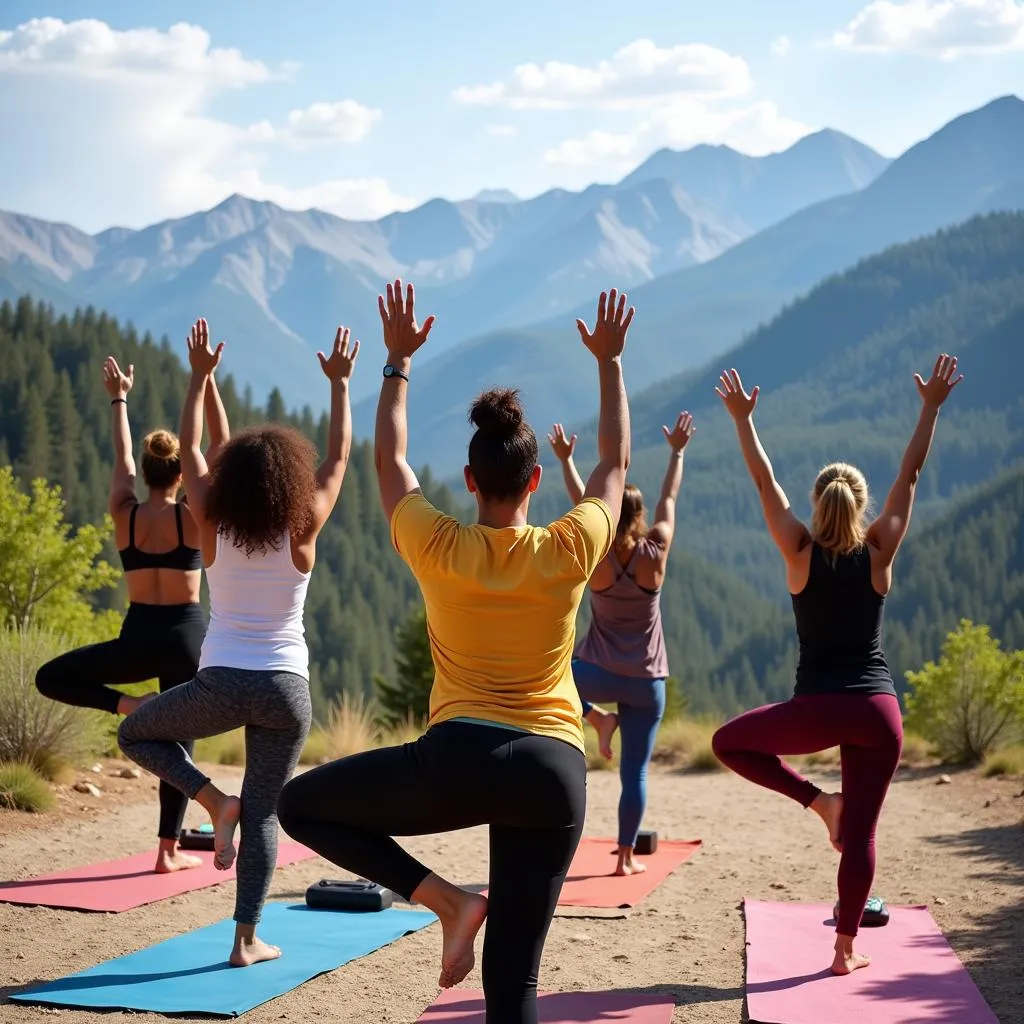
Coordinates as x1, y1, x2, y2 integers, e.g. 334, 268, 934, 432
0, 132, 889, 403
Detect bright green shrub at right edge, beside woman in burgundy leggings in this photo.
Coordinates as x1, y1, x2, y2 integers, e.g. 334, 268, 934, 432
906, 620, 1024, 764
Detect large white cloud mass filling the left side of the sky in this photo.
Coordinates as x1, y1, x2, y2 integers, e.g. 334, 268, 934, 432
0, 17, 399, 229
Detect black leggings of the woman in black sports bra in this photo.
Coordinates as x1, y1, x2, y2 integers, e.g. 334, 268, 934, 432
36, 604, 206, 839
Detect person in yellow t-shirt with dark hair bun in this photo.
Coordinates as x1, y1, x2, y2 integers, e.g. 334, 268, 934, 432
279, 281, 634, 1024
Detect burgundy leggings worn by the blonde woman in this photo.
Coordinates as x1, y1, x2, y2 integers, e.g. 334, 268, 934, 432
713, 693, 903, 935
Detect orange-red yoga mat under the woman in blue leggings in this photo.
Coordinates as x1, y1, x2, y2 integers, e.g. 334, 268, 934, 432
558, 839, 700, 907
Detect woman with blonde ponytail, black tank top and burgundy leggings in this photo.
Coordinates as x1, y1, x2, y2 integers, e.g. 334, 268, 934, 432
714, 355, 963, 975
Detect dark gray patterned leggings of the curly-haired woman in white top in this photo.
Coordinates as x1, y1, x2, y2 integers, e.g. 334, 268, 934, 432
118, 668, 312, 925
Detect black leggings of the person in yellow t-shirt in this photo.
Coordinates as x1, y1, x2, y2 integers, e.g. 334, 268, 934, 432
278, 722, 587, 1024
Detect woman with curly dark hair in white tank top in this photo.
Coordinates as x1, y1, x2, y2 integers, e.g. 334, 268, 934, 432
119, 319, 359, 967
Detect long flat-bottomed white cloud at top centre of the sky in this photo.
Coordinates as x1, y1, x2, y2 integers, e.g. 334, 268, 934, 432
455, 39, 751, 110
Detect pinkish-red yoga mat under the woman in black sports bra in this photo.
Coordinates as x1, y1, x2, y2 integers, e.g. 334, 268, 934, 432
0, 843, 315, 913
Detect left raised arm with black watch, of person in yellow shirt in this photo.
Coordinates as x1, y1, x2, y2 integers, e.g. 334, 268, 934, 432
374, 281, 435, 522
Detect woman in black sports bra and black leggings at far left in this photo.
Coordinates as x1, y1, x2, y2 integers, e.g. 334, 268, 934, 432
36, 356, 227, 872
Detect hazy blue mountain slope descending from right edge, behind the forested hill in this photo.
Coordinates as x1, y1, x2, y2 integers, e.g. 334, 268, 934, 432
370, 96, 1024, 473
